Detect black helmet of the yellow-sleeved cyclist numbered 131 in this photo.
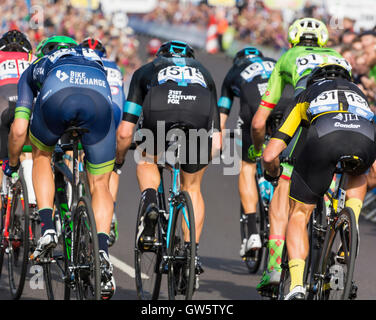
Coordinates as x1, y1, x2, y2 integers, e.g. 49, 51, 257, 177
307, 63, 353, 87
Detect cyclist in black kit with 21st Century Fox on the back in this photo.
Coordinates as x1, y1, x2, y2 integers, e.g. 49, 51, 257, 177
115, 41, 221, 273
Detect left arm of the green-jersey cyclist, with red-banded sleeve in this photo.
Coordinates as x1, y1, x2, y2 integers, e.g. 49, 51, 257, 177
251, 57, 285, 151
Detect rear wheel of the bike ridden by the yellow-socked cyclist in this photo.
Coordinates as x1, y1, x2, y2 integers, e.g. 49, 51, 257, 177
318, 207, 358, 300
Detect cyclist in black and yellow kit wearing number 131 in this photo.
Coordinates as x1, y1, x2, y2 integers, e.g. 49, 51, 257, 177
263, 63, 376, 300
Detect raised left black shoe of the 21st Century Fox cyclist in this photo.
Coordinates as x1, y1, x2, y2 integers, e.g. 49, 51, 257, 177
137, 203, 159, 250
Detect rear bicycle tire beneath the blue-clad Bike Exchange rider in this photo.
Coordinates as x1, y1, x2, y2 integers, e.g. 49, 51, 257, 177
73, 196, 101, 300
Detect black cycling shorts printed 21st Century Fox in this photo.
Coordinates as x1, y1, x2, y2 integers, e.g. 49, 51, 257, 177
136, 83, 216, 173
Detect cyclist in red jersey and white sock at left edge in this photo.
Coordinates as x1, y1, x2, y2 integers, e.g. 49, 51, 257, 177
0, 30, 36, 205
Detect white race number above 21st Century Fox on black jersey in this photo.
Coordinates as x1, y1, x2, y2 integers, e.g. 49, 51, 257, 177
158, 66, 207, 88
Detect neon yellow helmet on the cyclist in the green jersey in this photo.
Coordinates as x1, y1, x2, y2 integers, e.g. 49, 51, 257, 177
288, 18, 329, 47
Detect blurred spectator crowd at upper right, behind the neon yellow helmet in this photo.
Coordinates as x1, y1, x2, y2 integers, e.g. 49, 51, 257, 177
143, 0, 376, 105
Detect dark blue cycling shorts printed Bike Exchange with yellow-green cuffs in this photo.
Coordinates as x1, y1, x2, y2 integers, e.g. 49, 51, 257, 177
30, 65, 116, 175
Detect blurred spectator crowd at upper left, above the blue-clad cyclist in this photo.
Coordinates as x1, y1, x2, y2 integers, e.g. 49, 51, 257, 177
0, 0, 141, 81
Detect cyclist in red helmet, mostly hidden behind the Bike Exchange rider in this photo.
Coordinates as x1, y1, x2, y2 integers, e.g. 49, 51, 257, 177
80, 38, 125, 246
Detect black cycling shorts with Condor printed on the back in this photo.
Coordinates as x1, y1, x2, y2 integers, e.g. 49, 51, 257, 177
290, 113, 376, 204
